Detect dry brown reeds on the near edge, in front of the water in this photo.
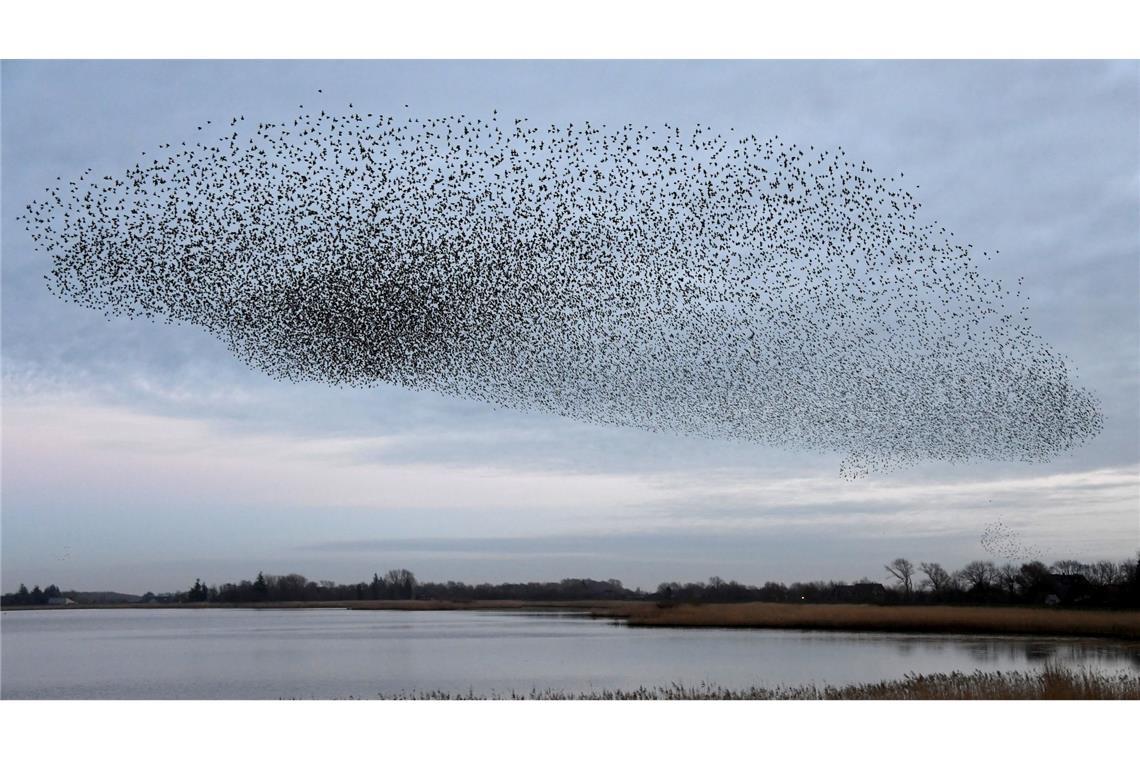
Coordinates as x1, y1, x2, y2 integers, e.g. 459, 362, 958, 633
384, 668, 1140, 701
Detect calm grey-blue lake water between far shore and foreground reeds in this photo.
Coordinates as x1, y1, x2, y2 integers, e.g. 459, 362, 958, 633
0, 610, 1140, 700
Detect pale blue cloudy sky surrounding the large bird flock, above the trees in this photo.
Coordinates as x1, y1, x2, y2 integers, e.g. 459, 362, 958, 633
0, 60, 1140, 593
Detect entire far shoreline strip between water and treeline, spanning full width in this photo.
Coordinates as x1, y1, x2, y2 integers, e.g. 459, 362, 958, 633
3, 599, 1140, 641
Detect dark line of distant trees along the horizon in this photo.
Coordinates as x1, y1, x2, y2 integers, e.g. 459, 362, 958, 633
0, 557, 1140, 607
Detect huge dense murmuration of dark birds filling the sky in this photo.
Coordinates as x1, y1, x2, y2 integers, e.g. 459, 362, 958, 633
24, 105, 1101, 476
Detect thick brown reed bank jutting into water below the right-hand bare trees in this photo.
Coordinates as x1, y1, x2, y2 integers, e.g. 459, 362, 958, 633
595, 602, 1140, 640
